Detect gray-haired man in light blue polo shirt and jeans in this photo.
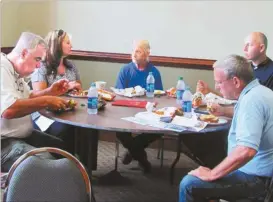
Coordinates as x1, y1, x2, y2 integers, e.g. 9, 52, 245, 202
179, 55, 273, 202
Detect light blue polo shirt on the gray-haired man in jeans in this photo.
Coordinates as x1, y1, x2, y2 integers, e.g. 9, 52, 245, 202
228, 79, 273, 177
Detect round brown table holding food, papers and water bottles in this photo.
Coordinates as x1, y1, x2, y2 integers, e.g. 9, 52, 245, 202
40, 96, 230, 183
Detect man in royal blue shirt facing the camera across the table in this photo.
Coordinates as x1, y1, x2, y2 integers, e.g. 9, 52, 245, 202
116, 40, 163, 172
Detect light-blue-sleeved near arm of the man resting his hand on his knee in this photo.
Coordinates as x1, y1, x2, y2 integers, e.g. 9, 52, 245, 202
208, 99, 266, 180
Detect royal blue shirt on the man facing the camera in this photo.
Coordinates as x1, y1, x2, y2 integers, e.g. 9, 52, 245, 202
116, 62, 163, 90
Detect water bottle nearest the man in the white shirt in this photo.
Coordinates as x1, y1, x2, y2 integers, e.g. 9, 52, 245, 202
87, 83, 98, 114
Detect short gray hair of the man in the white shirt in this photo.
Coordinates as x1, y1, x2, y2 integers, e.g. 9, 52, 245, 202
12, 32, 47, 54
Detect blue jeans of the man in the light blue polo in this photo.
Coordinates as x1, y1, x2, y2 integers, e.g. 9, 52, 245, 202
179, 170, 269, 202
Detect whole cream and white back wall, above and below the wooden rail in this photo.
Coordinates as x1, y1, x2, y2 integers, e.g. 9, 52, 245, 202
1, 0, 273, 90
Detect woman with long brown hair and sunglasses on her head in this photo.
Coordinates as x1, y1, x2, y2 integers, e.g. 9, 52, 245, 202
31, 29, 79, 153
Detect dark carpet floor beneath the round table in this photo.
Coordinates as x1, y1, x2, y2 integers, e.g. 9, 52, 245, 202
92, 141, 198, 202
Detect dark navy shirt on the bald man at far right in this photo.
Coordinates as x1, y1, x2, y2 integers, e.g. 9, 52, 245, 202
252, 58, 273, 90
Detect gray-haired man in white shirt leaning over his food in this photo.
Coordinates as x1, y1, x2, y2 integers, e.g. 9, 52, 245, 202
1, 32, 68, 172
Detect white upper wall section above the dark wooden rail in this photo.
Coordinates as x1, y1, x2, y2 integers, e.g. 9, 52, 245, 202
52, 1, 273, 59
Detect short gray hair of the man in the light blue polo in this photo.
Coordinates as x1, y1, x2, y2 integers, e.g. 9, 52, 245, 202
213, 55, 254, 85
